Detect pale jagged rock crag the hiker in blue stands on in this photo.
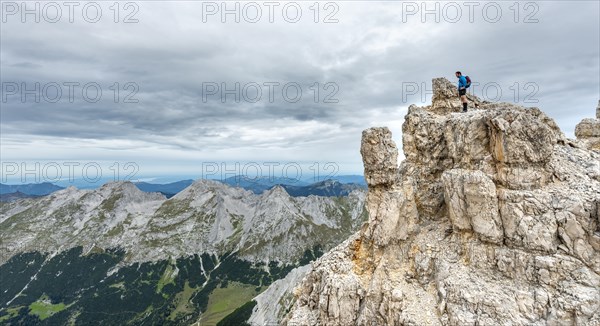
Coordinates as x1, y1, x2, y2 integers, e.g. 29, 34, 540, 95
284, 79, 600, 325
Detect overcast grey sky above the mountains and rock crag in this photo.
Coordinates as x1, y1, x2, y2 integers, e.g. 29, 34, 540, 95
0, 1, 600, 181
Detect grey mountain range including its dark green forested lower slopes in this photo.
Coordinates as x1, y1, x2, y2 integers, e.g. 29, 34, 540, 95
0, 180, 366, 325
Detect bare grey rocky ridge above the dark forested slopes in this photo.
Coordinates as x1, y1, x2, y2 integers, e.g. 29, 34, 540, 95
0, 180, 366, 264
